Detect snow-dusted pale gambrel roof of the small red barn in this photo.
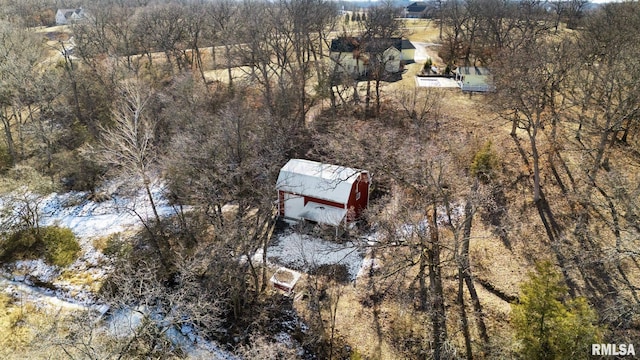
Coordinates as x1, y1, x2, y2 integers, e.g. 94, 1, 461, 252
276, 159, 367, 204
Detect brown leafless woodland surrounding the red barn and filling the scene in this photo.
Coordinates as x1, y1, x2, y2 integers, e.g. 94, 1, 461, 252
0, 0, 640, 359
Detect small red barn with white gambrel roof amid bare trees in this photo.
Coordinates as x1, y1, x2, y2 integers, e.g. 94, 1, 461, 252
276, 159, 371, 226
